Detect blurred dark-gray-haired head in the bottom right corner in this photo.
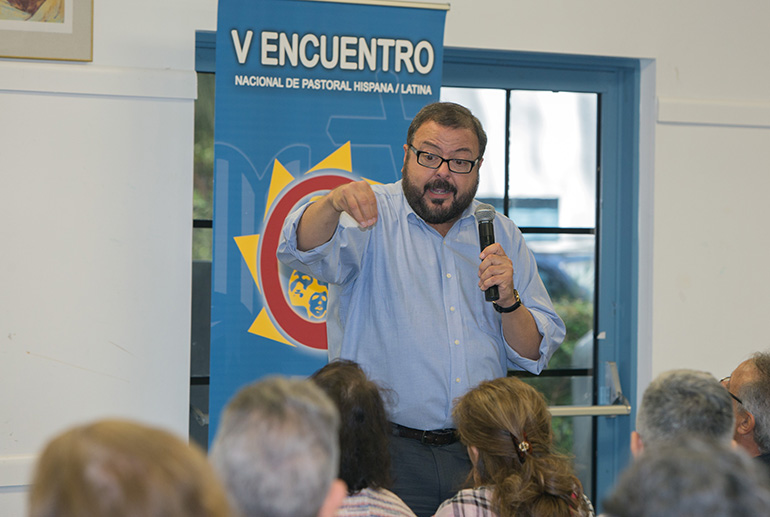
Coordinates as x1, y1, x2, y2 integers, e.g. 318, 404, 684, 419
604, 437, 770, 517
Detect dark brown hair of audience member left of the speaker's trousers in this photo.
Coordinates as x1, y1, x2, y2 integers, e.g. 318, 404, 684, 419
311, 359, 391, 494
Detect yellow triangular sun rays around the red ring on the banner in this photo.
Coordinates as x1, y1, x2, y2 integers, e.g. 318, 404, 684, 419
234, 142, 376, 346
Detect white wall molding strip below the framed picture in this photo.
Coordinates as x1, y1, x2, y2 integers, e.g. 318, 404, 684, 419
0, 61, 197, 100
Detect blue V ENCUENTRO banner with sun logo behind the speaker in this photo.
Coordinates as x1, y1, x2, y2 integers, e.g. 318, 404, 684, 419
209, 0, 447, 437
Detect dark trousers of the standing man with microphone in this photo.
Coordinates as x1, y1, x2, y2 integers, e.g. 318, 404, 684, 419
390, 436, 471, 517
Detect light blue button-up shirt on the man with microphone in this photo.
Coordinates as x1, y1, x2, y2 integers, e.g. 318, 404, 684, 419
278, 181, 565, 429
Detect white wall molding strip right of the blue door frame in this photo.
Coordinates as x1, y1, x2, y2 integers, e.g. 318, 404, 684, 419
658, 98, 770, 128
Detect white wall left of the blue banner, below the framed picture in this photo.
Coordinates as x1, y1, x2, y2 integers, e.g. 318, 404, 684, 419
0, 0, 207, 517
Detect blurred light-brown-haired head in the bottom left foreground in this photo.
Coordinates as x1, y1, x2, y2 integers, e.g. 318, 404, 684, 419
29, 420, 230, 517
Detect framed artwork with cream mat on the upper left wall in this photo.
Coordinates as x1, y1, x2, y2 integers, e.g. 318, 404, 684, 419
0, 0, 94, 61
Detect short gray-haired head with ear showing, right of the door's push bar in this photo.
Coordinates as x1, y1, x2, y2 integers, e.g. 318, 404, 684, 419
631, 370, 735, 456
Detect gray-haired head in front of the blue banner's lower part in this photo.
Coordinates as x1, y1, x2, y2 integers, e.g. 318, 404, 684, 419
210, 376, 346, 517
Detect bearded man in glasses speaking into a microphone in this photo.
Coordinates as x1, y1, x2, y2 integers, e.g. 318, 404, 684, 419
278, 102, 564, 516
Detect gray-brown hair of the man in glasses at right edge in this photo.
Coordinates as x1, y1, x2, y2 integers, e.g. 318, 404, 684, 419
736, 352, 770, 454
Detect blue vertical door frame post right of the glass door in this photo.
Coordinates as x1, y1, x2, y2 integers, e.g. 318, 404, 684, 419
596, 65, 640, 511
